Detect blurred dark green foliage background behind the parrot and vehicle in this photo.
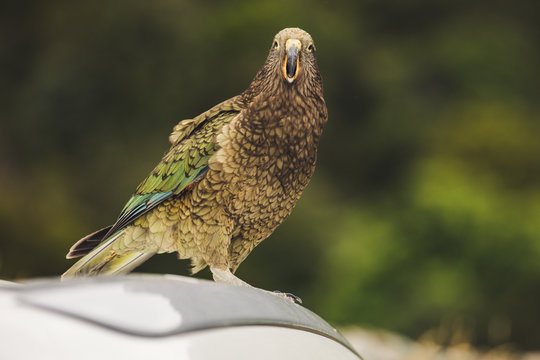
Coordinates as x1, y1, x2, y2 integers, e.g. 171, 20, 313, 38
0, 0, 540, 350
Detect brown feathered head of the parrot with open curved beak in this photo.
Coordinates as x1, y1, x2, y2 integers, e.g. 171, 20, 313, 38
248, 28, 322, 94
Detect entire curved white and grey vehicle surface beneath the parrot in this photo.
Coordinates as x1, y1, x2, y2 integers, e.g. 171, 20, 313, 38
0, 275, 361, 360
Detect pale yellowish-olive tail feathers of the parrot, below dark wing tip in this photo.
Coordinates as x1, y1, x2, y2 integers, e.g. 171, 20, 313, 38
62, 230, 155, 279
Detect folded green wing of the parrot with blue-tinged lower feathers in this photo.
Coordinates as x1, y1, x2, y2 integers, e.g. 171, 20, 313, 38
104, 97, 243, 238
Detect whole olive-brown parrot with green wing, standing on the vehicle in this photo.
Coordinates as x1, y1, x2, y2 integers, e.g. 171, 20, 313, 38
62, 28, 328, 296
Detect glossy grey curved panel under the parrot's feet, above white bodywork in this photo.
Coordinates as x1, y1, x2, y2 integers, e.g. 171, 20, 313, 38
5, 274, 356, 353
